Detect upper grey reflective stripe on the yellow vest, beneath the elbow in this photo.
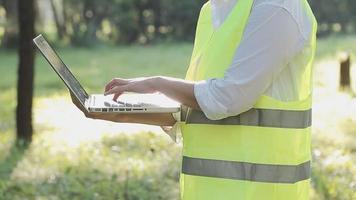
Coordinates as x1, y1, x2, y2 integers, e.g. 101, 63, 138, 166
186, 108, 312, 129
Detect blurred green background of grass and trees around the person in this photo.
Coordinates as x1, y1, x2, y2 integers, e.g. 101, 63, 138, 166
0, 0, 356, 200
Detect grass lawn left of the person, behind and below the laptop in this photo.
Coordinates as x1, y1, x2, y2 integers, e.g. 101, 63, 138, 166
0, 44, 192, 199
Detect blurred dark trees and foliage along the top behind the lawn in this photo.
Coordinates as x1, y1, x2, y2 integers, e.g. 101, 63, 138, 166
0, 0, 356, 47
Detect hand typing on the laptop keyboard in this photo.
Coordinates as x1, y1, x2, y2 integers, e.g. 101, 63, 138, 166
105, 77, 157, 101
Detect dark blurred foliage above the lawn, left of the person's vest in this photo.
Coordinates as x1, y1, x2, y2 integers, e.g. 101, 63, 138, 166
64, 0, 204, 45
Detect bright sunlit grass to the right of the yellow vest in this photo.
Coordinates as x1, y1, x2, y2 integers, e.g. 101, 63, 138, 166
312, 36, 356, 200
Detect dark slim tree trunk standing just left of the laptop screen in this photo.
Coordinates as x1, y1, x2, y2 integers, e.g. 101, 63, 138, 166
16, 0, 35, 143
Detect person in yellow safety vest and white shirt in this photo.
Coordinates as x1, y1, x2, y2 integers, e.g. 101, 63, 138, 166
71, 0, 316, 200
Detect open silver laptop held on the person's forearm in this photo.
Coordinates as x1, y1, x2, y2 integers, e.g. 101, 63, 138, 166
33, 35, 180, 113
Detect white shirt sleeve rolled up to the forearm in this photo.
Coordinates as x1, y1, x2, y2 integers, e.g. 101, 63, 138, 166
194, 4, 304, 120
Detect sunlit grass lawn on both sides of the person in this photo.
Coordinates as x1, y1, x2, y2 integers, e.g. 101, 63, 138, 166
0, 36, 356, 200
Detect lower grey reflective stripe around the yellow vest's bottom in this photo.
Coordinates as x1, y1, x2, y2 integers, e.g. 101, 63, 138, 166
182, 156, 310, 183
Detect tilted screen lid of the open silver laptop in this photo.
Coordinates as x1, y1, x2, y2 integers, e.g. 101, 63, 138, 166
33, 35, 88, 105
